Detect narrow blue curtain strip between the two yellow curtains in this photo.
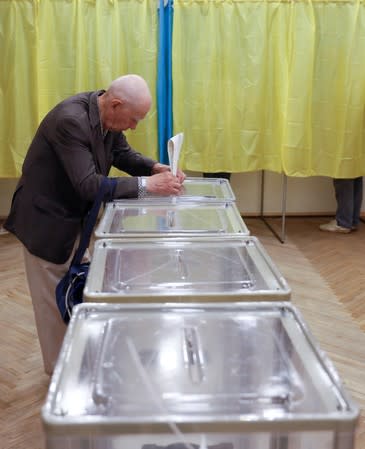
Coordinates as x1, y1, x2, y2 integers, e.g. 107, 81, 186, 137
156, 0, 173, 164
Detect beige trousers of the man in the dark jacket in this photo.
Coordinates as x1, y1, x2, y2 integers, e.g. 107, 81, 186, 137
24, 243, 89, 375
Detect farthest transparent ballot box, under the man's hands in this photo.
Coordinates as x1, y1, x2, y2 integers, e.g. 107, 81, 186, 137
138, 177, 236, 201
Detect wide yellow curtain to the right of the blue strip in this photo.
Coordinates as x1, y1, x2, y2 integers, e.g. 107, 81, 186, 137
172, 0, 365, 178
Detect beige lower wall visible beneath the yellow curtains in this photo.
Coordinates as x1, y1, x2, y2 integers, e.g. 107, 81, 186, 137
0, 172, 365, 217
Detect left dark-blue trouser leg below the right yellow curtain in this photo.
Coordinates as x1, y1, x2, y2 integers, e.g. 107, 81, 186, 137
333, 179, 354, 229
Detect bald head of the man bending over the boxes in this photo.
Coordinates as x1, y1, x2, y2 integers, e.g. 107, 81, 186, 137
98, 75, 152, 131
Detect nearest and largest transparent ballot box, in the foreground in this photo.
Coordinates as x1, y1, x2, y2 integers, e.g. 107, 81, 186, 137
42, 302, 359, 449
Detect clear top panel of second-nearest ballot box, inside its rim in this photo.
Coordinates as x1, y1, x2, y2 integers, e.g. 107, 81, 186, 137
102, 242, 258, 295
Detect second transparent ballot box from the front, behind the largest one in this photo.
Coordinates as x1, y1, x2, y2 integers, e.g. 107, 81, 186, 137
84, 236, 290, 302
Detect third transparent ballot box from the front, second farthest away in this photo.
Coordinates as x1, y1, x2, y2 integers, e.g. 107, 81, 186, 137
95, 198, 249, 238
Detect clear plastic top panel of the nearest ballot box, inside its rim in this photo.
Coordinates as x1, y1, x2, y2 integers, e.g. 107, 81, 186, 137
54, 309, 346, 422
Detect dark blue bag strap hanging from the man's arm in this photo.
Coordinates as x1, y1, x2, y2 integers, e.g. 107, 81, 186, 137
71, 177, 117, 266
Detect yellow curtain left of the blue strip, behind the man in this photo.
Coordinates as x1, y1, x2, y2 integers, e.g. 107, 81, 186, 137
0, 0, 157, 177
